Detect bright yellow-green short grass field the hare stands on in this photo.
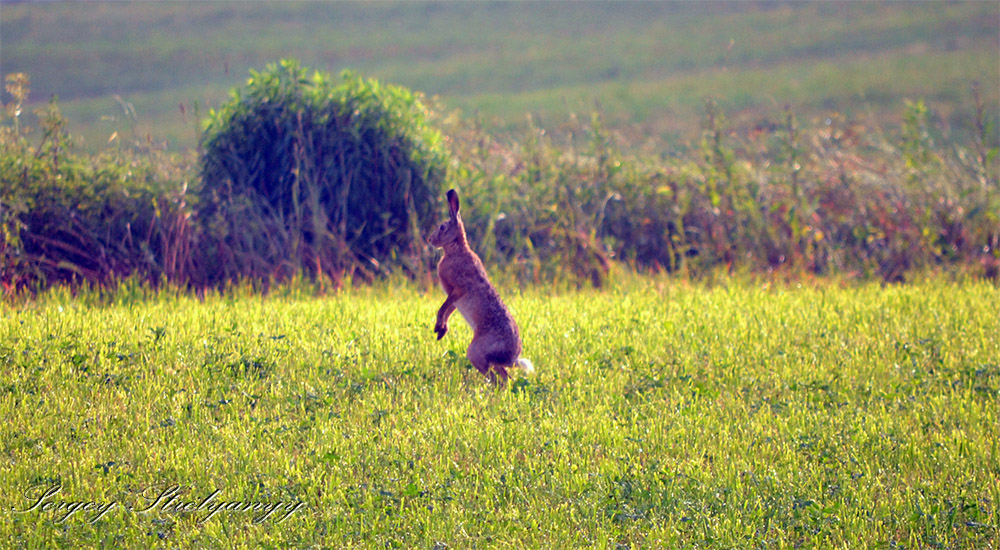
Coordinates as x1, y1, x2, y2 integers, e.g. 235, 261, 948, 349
0, 279, 1000, 549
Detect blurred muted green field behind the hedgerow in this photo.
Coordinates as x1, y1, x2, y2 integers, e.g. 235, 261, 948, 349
0, 2, 1000, 149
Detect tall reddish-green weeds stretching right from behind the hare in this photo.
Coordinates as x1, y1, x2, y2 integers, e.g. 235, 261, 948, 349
446, 88, 1000, 284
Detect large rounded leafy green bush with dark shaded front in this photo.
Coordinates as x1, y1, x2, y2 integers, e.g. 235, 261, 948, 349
195, 60, 447, 283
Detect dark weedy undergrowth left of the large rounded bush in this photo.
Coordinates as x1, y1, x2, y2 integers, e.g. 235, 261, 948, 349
0, 74, 190, 292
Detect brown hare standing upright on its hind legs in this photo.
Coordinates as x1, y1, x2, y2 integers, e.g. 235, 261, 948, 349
427, 189, 534, 385
